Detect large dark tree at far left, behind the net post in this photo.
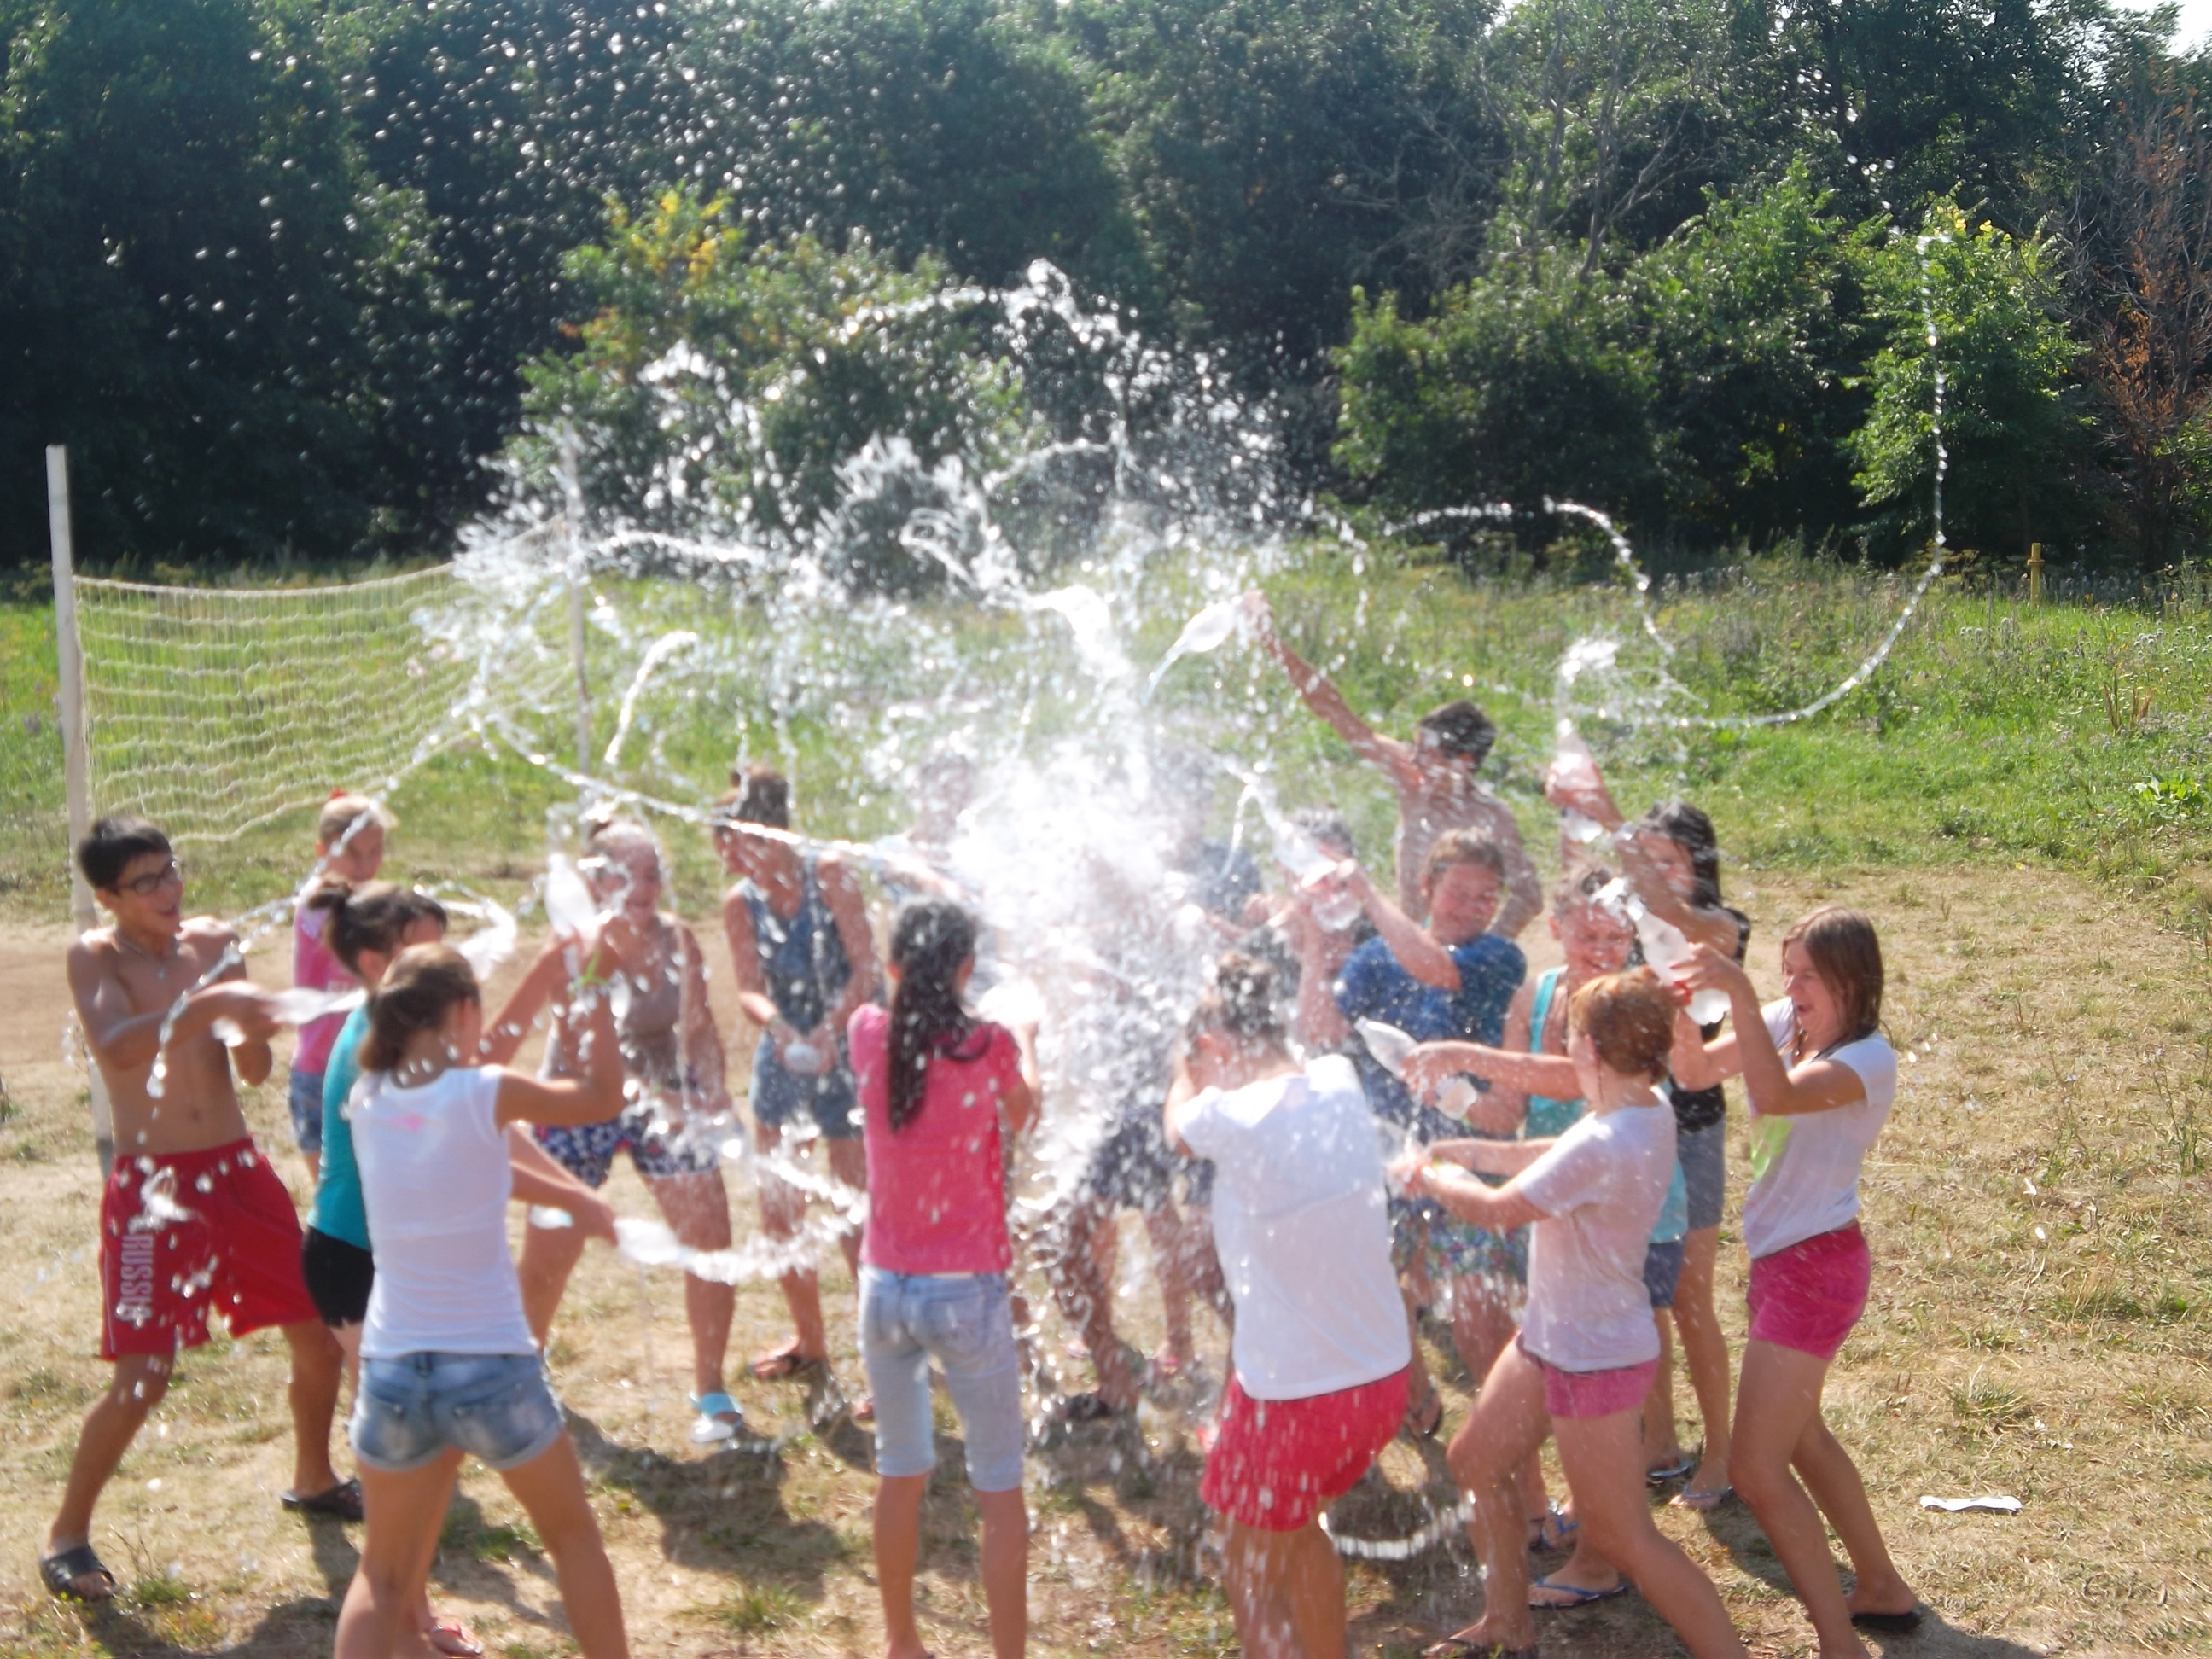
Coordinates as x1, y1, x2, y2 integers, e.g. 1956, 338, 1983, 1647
0, 0, 406, 564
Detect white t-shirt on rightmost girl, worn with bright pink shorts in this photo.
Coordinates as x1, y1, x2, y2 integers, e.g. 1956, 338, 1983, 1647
1743, 998, 1898, 1260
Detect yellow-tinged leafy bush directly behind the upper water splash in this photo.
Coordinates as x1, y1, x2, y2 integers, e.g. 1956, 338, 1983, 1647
518, 190, 1027, 588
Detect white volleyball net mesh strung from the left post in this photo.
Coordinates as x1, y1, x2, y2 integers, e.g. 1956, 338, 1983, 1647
75, 564, 568, 841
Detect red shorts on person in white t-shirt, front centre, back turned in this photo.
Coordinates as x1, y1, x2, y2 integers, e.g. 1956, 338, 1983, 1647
1199, 1371, 1407, 1533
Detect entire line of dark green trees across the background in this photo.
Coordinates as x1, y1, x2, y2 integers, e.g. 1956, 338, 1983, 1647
0, 0, 2212, 571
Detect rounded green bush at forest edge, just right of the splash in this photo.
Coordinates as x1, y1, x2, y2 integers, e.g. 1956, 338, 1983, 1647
1336, 254, 1655, 511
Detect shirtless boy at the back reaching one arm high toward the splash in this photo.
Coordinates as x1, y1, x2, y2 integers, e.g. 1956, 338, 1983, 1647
1245, 588, 1544, 938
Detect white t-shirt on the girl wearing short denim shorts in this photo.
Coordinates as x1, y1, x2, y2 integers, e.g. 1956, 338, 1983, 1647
347, 1066, 538, 1360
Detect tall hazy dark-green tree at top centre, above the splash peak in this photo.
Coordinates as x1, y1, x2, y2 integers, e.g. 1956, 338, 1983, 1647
1057, 0, 1498, 371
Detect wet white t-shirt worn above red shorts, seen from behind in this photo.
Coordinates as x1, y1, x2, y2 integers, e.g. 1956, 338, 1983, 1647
1174, 1055, 1413, 1400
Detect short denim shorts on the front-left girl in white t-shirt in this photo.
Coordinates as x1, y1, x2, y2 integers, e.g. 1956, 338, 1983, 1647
345, 1353, 564, 1476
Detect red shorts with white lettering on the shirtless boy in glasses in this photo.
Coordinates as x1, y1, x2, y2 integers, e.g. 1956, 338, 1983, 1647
100, 1137, 317, 1360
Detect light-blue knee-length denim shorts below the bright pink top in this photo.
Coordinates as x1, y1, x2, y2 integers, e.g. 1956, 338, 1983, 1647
860, 1266, 1024, 1491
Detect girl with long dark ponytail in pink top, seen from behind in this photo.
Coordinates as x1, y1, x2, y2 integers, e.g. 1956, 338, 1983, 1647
847, 898, 1038, 1659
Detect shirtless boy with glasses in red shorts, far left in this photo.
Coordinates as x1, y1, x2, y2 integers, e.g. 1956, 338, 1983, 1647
40, 818, 360, 1602
